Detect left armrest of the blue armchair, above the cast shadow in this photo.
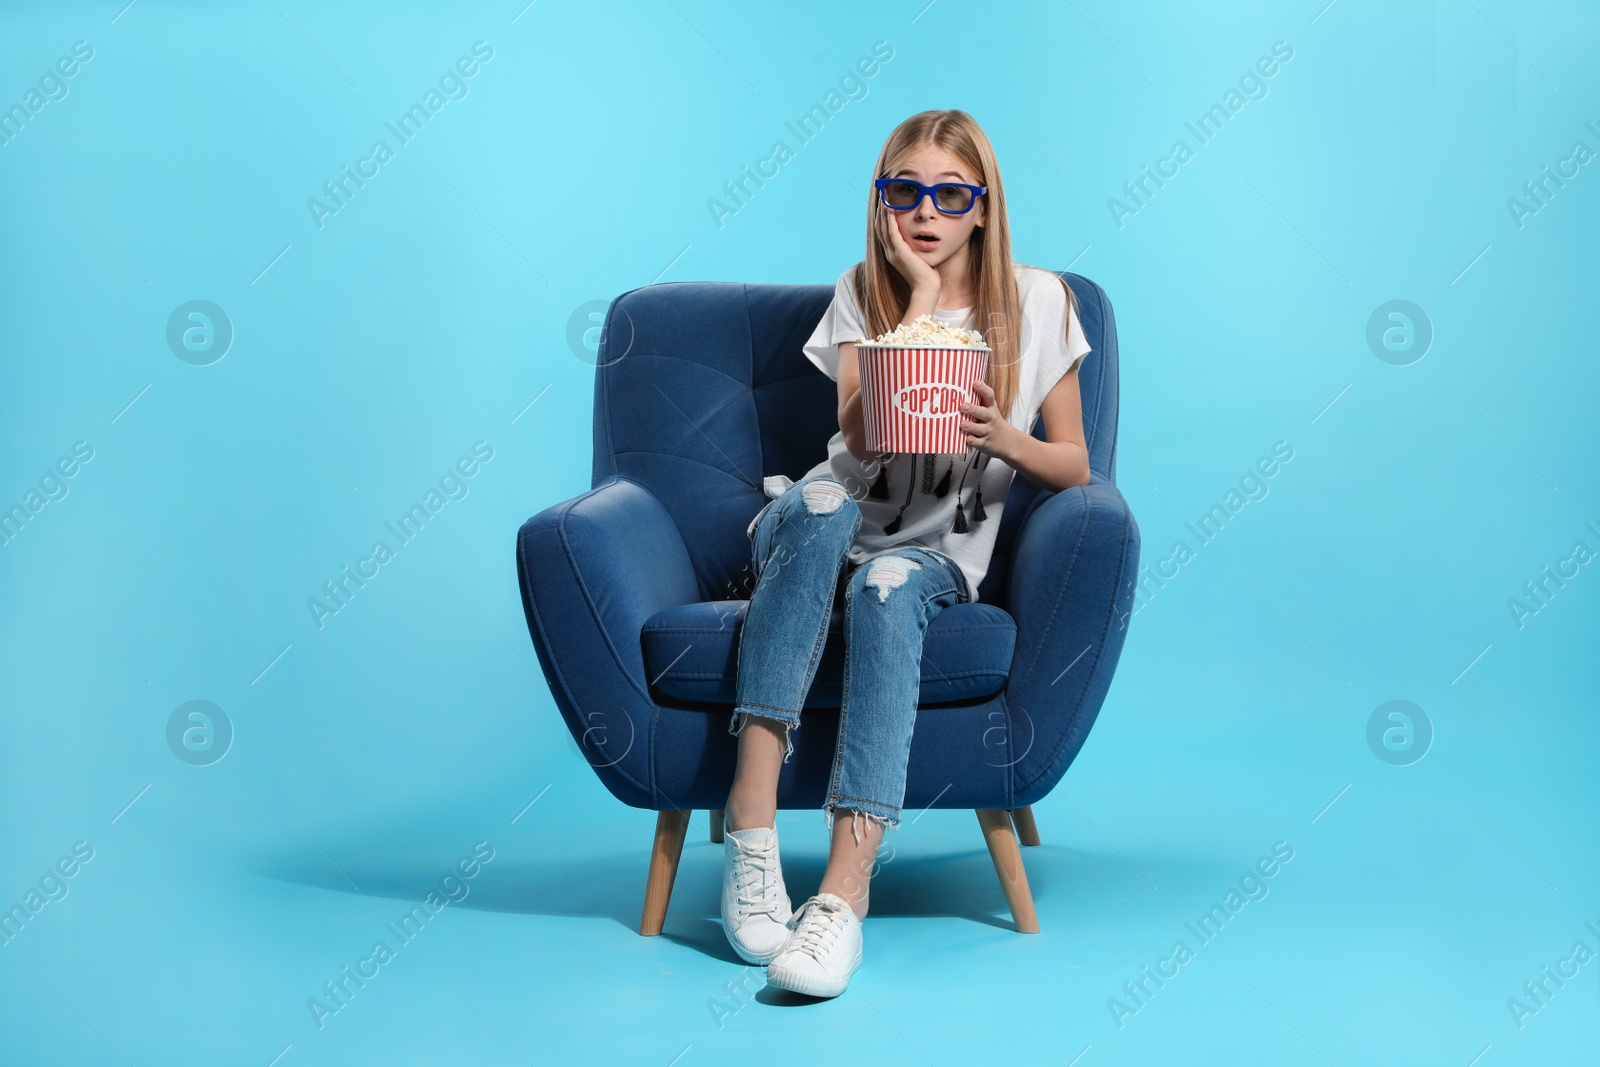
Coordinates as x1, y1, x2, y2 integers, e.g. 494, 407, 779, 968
517, 480, 699, 808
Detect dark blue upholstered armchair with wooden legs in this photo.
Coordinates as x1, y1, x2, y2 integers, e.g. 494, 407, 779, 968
517, 274, 1139, 934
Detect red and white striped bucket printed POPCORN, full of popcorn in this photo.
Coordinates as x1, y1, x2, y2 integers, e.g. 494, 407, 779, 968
856, 342, 989, 454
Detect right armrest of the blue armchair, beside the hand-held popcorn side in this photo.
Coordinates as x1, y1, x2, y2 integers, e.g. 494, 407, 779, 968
1005, 474, 1139, 806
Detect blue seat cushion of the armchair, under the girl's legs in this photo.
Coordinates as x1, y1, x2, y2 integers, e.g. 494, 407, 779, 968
640, 600, 1016, 707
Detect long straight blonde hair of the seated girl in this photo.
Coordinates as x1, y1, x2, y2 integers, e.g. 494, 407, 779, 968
853, 110, 1017, 418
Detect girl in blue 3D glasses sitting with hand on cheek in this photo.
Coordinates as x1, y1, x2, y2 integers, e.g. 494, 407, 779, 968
722, 110, 1090, 997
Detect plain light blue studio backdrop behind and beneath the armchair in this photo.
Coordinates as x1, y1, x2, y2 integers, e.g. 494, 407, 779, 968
0, 0, 1600, 1067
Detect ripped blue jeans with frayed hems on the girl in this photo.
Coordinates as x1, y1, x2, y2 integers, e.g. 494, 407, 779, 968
728, 475, 971, 841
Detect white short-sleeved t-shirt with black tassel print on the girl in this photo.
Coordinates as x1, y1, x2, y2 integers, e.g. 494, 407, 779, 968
746, 264, 1090, 601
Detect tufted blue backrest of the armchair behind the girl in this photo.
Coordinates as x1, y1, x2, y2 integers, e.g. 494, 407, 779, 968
592, 274, 1117, 608
